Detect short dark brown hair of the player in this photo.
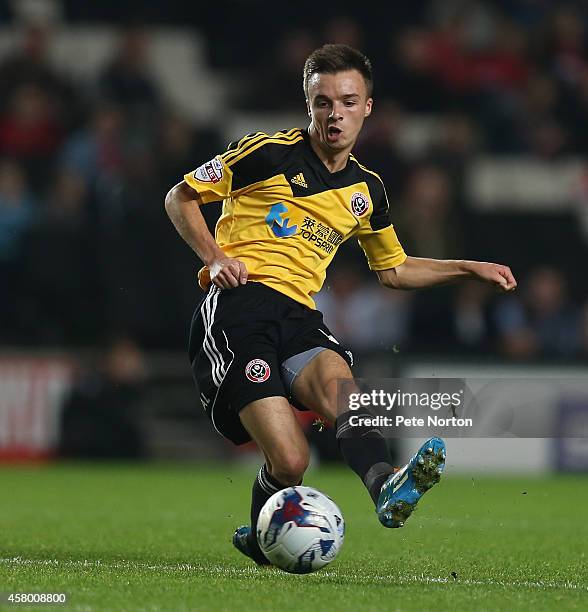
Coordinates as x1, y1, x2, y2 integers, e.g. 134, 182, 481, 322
302, 45, 374, 97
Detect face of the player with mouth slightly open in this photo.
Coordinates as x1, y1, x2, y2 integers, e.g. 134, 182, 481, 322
306, 70, 372, 153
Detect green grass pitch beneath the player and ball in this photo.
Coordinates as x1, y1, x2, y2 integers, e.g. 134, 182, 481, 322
0, 464, 588, 611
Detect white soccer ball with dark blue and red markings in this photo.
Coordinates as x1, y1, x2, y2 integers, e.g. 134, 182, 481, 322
257, 486, 345, 574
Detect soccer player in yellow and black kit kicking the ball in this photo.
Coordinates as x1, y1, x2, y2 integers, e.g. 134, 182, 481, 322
165, 45, 516, 564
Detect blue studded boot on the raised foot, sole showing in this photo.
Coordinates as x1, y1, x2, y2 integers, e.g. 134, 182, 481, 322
376, 438, 445, 527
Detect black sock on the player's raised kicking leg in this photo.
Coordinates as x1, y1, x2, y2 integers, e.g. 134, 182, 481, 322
337, 411, 394, 504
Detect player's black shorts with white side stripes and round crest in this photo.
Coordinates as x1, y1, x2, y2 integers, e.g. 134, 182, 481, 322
189, 282, 353, 444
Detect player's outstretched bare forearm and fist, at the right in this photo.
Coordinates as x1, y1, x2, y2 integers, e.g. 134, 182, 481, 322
375, 256, 517, 292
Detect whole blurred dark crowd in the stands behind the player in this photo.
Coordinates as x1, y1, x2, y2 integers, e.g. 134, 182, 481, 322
0, 0, 588, 360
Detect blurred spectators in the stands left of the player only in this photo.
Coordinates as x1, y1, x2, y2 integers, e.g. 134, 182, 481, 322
0, 26, 221, 348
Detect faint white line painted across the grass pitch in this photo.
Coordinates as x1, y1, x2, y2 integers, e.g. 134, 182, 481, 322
0, 557, 588, 591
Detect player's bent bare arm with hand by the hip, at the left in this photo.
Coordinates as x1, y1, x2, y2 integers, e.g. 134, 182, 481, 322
165, 180, 247, 289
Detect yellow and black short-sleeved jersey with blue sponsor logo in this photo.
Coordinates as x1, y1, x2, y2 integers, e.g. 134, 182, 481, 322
184, 128, 406, 308
